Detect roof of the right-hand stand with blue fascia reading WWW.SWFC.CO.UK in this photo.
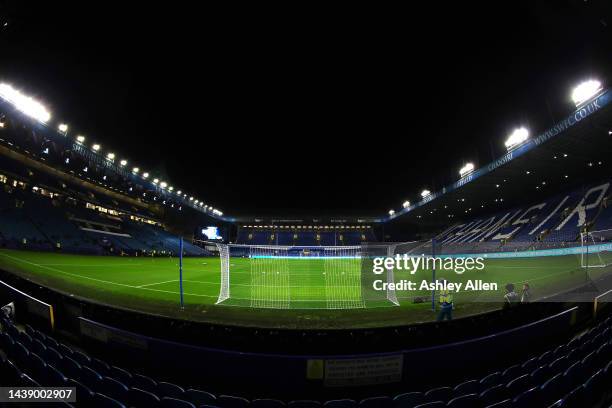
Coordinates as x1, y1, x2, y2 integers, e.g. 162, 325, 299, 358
388, 89, 612, 224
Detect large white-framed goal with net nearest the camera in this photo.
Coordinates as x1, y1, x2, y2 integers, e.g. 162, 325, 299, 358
217, 244, 399, 309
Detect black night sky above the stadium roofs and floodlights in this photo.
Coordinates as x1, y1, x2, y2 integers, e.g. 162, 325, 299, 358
0, 0, 612, 215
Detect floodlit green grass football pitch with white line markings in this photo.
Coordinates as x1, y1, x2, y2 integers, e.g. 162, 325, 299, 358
0, 250, 608, 329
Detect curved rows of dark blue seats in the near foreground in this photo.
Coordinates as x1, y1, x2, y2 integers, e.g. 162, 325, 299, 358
0, 317, 612, 408
